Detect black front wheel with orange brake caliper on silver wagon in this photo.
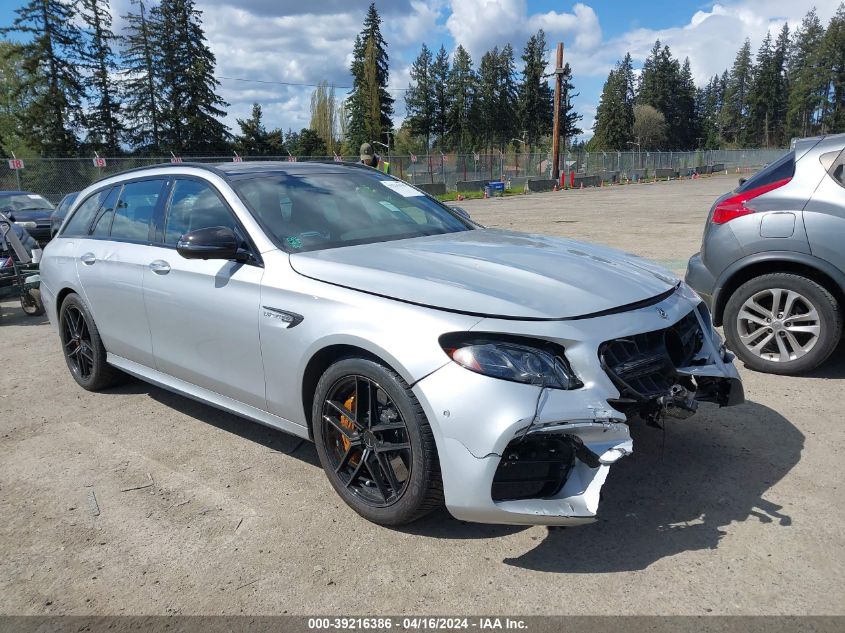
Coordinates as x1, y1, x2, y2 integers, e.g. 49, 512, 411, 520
312, 358, 443, 525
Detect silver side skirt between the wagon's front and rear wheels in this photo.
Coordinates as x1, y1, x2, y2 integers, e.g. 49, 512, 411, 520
106, 354, 310, 440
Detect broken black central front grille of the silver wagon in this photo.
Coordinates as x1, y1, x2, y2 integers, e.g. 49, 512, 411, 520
599, 310, 704, 402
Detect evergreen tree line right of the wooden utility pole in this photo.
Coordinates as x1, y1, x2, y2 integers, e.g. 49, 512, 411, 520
587, 3, 845, 150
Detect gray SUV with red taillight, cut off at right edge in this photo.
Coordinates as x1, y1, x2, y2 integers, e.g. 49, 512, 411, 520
686, 134, 845, 374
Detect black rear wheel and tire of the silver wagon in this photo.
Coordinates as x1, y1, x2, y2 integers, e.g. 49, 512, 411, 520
59, 293, 124, 391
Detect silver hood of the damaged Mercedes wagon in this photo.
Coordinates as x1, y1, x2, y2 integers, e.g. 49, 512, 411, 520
290, 229, 679, 319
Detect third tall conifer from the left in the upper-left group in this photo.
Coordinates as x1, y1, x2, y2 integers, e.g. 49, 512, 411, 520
122, 0, 162, 152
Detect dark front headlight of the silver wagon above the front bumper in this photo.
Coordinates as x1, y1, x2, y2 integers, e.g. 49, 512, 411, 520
440, 334, 584, 389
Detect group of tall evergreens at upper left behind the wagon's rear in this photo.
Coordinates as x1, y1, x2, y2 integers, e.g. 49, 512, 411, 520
0, 0, 228, 157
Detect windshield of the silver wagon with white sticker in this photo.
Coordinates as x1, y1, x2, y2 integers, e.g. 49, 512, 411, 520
233, 169, 473, 253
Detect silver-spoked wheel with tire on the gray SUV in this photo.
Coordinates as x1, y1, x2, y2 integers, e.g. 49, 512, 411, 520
724, 273, 842, 374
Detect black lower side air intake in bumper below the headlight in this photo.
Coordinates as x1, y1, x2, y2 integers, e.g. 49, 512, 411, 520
491, 433, 575, 501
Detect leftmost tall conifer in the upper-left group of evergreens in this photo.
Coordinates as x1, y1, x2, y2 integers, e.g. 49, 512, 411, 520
0, 0, 85, 157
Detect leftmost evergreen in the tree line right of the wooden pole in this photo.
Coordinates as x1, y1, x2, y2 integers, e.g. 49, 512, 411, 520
590, 53, 634, 150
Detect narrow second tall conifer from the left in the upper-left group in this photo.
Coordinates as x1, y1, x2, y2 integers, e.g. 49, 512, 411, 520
80, 0, 123, 156
